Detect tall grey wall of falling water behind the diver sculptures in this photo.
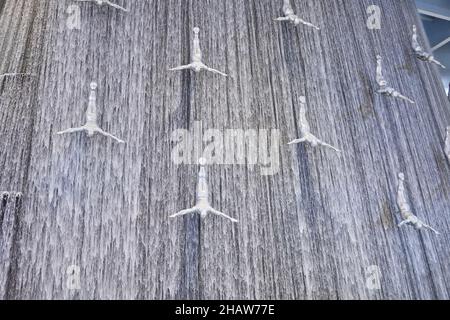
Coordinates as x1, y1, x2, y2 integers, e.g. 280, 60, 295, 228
0, 0, 450, 299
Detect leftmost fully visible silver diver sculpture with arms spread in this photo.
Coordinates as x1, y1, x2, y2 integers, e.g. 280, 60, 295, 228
57, 82, 125, 143
